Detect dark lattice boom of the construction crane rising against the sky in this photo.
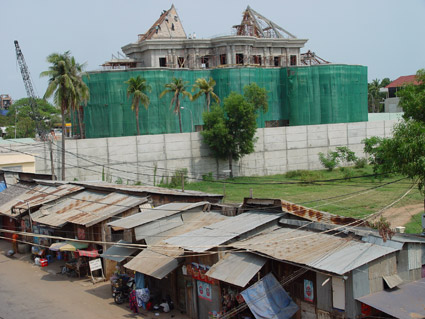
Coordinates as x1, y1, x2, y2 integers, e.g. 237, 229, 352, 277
15, 40, 46, 140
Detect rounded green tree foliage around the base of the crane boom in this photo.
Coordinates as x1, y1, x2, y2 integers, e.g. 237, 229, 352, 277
4, 98, 60, 138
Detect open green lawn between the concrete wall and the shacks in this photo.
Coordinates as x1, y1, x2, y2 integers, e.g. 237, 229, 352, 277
185, 166, 423, 218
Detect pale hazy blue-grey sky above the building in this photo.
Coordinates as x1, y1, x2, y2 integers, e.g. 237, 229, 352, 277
0, 0, 425, 99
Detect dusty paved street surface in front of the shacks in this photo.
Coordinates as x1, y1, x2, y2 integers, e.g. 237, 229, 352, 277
0, 240, 188, 319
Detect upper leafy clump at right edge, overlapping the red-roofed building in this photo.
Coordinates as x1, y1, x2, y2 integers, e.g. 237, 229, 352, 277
397, 69, 425, 122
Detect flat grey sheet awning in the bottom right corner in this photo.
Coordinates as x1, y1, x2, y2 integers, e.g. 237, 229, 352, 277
357, 278, 425, 319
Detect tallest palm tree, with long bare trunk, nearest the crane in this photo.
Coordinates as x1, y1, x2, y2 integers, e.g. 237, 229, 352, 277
40, 51, 78, 180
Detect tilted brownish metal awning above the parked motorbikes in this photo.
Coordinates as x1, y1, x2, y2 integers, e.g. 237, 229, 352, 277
124, 249, 179, 279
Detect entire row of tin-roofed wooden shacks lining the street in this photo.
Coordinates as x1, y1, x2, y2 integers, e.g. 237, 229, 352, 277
0, 172, 425, 318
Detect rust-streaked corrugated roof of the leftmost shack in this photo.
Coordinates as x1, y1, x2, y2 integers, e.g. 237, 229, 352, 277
0, 185, 84, 217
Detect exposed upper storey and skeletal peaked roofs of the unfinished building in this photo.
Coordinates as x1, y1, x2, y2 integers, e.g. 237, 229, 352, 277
122, 5, 307, 69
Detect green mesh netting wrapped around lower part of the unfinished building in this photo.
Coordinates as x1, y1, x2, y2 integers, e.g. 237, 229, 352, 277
80, 65, 368, 138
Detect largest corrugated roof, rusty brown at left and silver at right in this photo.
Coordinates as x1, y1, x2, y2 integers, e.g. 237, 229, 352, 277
232, 228, 399, 275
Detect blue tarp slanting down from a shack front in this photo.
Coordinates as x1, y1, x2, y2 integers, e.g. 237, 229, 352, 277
241, 273, 299, 319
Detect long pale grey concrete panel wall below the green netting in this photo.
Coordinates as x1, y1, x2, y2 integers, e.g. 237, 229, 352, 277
0, 120, 397, 185
